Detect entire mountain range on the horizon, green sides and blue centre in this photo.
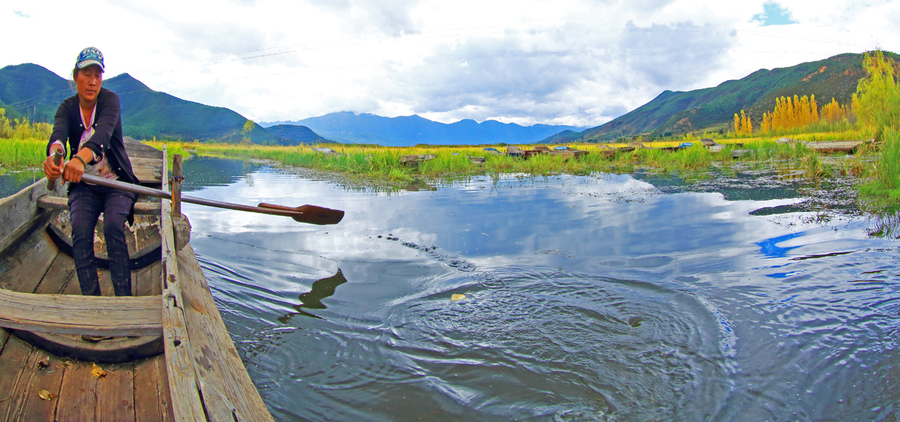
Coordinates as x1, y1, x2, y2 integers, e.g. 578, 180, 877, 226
0, 52, 884, 146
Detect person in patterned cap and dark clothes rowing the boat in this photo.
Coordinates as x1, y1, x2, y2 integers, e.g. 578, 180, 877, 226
44, 47, 137, 310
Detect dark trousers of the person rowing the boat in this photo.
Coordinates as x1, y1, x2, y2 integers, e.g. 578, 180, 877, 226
69, 183, 136, 296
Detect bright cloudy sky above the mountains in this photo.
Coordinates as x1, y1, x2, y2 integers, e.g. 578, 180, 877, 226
0, 0, 900, 126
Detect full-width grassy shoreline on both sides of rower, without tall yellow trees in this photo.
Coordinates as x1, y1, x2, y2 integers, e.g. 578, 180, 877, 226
0, 126, 900, 208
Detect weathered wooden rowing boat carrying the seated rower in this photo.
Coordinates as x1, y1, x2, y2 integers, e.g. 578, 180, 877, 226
0, 142, 272, 421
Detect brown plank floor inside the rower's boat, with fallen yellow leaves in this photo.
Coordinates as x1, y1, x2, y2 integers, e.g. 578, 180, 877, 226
0, 209, 174, 421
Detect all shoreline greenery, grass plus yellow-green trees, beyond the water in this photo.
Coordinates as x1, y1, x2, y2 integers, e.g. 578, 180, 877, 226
0, 51, 900, 212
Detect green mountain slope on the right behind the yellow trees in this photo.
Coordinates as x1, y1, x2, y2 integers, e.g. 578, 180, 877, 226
579, 53, 884, 142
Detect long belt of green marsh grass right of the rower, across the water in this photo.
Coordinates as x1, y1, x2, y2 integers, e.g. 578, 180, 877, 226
137, 131, 876, 184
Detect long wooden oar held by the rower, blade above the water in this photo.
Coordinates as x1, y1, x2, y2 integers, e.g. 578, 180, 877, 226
81, 174, 344, 225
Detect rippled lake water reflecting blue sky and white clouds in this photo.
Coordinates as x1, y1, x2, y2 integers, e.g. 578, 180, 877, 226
8, 158, 900, 421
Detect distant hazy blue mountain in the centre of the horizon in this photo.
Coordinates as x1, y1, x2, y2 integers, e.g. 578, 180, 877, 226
260, 112, 585, 146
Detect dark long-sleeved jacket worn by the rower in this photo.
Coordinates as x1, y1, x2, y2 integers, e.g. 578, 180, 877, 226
47, 88, 138, 183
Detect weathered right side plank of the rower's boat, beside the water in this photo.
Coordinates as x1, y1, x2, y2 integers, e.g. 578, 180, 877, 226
160, 147, 273, 421
